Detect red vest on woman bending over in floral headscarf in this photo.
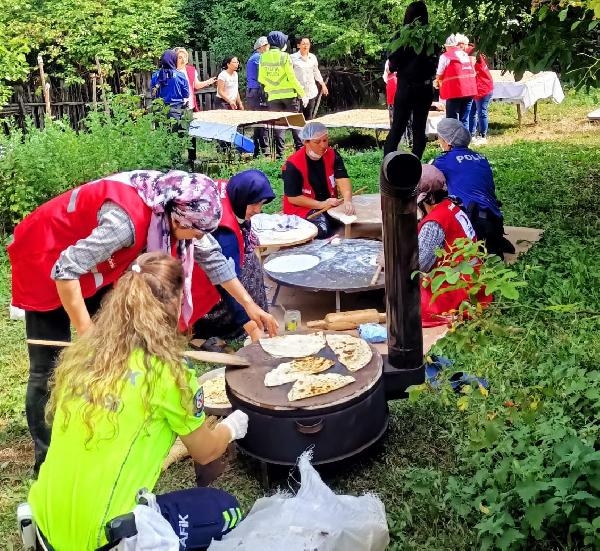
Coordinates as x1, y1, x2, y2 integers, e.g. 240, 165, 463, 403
8, 179, 152, 312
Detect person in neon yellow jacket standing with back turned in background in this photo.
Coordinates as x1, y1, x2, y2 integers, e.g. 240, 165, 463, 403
258, 31, 308, 159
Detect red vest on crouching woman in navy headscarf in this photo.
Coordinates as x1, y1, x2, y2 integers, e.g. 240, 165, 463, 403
179, 180, 244, 329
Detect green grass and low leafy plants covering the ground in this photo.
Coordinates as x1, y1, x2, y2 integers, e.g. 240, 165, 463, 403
0, 91, 600, 550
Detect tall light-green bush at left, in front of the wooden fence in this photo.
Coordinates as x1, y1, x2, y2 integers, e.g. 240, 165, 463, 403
0, 98, 187, 233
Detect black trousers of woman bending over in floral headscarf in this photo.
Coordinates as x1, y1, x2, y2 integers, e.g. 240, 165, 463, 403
25, 287, 110, 474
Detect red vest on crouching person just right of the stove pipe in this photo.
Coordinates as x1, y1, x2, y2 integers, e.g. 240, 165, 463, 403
419, 199, 492, 327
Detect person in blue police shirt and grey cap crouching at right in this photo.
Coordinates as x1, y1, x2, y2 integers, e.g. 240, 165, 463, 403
433, 118, 515, 258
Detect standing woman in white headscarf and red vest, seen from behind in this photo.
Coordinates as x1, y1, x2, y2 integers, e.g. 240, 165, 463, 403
436, 34, 477, 130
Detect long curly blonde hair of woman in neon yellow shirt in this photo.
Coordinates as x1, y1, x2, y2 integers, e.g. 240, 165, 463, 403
46, 253, 191, 441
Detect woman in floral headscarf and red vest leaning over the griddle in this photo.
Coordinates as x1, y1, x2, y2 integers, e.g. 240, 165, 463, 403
8, 170, 277, 471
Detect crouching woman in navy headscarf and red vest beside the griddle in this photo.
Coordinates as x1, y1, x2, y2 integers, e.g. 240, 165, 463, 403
194, 169, 275, 341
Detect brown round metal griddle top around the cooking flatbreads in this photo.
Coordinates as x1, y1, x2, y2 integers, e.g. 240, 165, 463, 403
225, 331, 383, 410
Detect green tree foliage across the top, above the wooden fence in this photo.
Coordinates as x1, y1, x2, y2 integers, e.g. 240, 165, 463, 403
0, 0, 600, 103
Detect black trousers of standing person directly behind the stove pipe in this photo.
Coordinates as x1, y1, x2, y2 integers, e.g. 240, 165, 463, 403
383, 79, 433, 159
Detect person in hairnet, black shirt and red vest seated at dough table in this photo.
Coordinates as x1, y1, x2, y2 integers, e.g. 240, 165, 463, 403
282, 121, 355, 239
